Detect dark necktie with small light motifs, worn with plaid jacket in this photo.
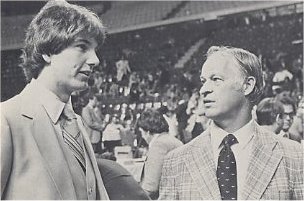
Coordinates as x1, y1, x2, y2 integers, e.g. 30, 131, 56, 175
216, 134, 238, 200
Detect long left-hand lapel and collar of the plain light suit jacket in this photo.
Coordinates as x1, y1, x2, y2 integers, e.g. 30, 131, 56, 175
21, 83, 76, 199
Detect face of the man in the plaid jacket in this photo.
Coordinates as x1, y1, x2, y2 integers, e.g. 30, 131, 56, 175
200, 53, 246, 121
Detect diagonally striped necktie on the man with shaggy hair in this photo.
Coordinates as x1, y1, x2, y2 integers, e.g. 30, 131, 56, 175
60, 104, 85, 172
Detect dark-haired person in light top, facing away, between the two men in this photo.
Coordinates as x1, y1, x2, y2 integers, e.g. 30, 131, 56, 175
136, 109, 183, 199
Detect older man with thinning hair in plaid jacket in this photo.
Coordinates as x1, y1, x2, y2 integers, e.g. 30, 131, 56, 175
160, 47, 303, 200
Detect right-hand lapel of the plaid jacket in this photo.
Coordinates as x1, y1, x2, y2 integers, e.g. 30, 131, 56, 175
241, 125, 282, 200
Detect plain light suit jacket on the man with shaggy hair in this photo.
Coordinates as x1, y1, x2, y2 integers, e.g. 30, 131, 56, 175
1, 84, 108, 200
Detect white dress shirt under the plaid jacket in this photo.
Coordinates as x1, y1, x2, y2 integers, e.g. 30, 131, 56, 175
210, 120, 254, 199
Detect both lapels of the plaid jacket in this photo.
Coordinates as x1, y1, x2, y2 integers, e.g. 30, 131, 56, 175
184, 123, 283, 200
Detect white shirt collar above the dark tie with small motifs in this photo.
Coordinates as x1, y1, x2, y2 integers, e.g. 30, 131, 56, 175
210, 120, 254, 150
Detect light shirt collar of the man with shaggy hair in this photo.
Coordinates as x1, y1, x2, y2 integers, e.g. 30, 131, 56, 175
31, 79, 67, 124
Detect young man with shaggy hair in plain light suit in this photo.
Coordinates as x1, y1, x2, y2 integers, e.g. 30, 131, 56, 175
1, 1, 108, 200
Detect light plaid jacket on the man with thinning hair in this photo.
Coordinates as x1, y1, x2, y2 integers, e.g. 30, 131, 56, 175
160, 124, 303, 200
